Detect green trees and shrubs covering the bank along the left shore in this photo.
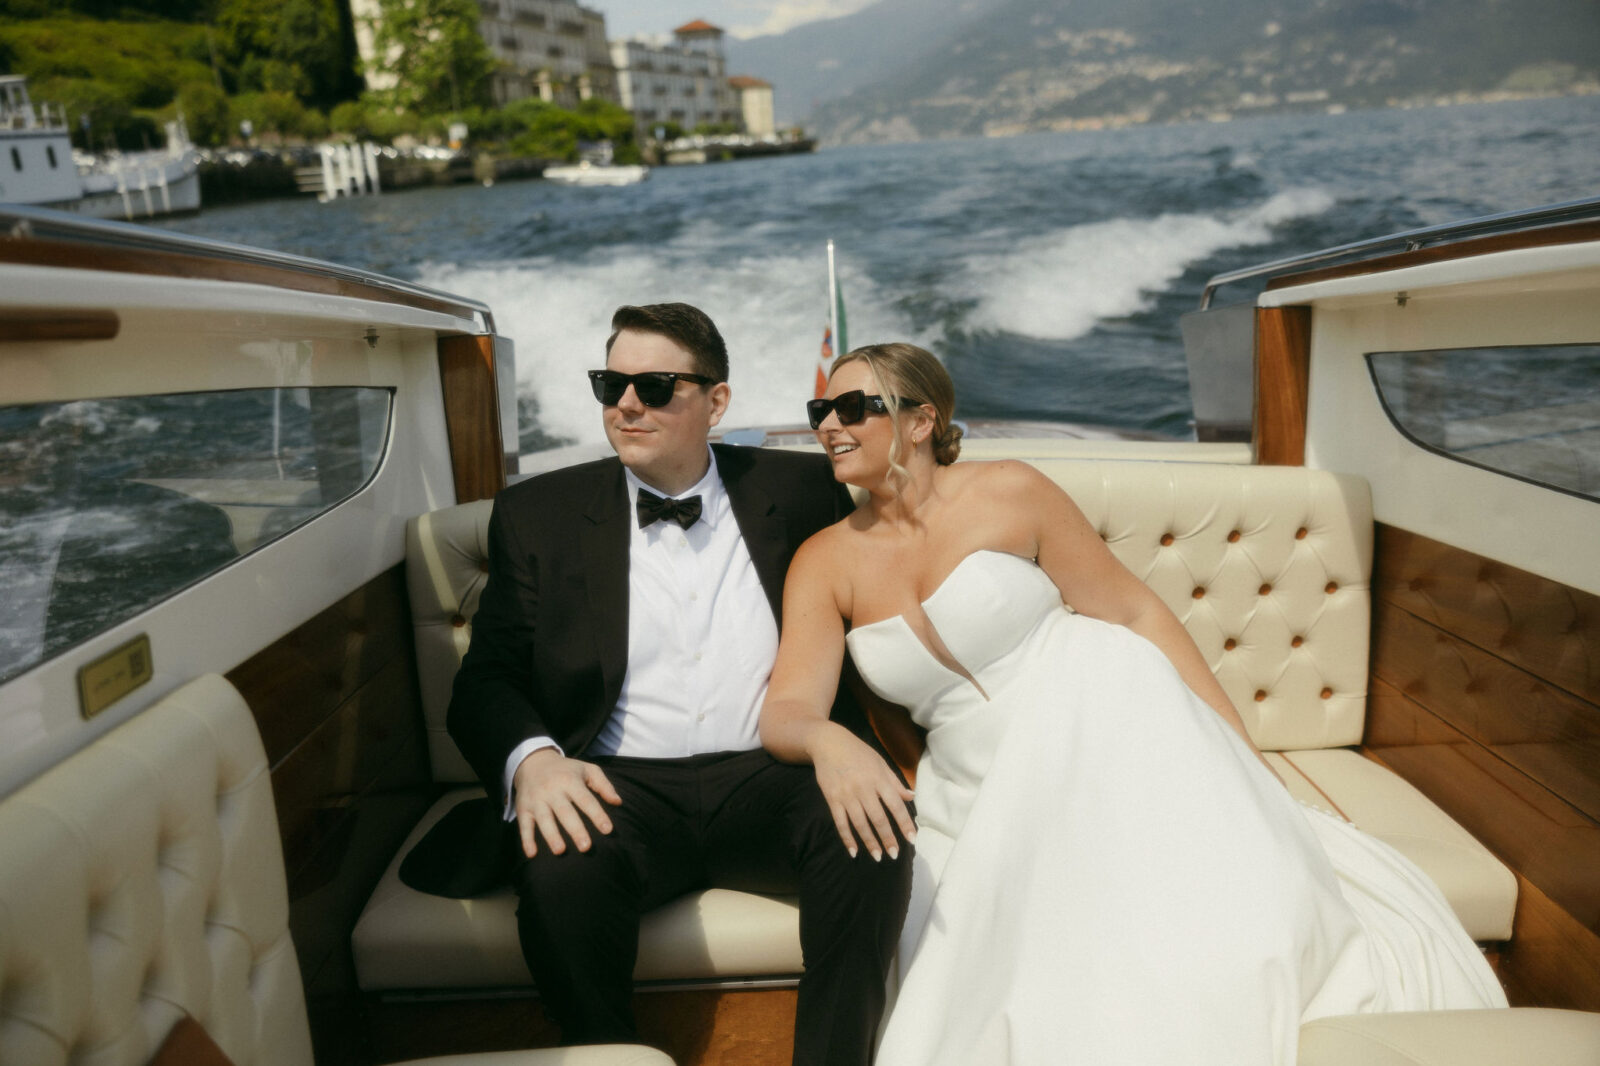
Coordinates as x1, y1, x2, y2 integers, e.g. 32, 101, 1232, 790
0, 0, 637, 162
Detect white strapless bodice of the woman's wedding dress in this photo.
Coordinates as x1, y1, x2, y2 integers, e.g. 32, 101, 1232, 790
846, 551, 1062, 728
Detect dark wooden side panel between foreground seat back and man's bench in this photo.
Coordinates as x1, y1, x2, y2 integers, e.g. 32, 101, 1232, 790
227, 565, 438, 1063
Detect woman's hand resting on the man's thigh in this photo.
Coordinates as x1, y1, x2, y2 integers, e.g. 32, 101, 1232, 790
808, 722, 917, 861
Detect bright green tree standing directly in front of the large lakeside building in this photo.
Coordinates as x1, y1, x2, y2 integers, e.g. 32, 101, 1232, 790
368, 0, 494, 114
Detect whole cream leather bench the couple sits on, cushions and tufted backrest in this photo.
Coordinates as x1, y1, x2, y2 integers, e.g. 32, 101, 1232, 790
354, 459, 1517, 991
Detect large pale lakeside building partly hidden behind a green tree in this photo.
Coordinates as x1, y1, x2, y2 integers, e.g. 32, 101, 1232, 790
350, 0, 622, 107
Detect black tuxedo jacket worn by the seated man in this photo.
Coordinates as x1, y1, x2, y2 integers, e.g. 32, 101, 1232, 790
448, 445, 877, 807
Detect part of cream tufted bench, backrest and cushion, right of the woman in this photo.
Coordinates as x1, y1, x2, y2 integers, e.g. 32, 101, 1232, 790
1035, 459, 1517, 941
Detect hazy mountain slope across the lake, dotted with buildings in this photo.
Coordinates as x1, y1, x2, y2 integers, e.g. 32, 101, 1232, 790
742, 0, 1600, 142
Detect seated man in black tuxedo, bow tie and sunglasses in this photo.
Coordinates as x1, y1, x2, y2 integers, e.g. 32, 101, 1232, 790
448, 304, 910, 1066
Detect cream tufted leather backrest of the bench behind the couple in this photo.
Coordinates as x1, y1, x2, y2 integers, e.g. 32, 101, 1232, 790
406, 459, 1373, 781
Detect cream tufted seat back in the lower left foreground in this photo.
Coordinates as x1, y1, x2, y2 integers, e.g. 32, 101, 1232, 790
0, 675, 312, 1066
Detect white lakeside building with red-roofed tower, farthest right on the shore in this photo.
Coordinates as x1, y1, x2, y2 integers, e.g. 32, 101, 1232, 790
611, 19, 742, 134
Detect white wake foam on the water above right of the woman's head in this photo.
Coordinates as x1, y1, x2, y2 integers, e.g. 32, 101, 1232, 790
966, 189, 1334, 341
